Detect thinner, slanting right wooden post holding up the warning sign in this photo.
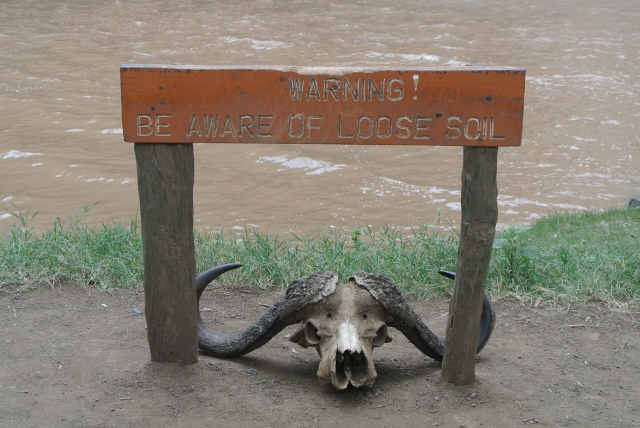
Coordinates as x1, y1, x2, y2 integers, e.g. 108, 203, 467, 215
442, 147, 498, 385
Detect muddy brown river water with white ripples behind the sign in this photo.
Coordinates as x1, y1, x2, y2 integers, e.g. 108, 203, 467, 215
0, 0, 640, 233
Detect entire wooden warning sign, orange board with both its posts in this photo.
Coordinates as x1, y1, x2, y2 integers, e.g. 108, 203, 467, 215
120, 65, 525, 378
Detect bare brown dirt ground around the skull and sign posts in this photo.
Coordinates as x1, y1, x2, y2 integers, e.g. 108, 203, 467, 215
0, 285, 640, 428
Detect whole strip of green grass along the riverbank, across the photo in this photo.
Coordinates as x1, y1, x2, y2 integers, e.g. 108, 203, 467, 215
0, 208, 640, 306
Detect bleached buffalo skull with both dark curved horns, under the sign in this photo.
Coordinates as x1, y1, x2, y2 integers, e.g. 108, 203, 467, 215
196, 264, 495, 390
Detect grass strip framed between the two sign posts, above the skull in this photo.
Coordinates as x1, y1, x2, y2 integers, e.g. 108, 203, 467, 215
196, 219, 457, 296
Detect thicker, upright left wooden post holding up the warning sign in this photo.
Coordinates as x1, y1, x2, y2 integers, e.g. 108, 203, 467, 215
134, 143, 198, 364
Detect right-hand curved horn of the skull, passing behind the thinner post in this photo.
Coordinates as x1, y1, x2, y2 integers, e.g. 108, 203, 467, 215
351, 273, 495, 361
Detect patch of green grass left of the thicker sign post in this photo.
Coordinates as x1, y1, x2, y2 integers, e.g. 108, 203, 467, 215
0, 207, 143, 289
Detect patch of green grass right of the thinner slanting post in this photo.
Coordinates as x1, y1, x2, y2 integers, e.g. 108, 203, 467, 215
490, 208, 640, 306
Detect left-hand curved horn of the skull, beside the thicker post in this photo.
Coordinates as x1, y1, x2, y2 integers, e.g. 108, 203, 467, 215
196, 264, 338, 358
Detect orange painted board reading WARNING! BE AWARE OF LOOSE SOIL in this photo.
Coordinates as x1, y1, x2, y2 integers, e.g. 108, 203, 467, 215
120, 64, 525, 147
